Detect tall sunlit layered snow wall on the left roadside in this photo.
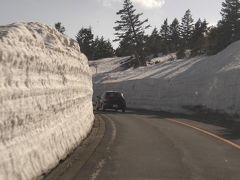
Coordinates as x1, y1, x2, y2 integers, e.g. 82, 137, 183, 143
0, 23, 94, 180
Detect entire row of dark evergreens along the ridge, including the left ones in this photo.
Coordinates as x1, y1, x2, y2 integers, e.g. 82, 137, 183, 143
55, 0, 240, 67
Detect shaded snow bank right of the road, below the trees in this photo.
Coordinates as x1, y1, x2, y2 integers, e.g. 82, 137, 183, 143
90, 41, 240, 118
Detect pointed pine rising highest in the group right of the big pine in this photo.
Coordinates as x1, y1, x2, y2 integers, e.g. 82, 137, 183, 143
180, 9, 194, 48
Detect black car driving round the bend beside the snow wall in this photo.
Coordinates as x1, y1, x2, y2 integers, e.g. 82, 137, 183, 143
96, 91, 126, 112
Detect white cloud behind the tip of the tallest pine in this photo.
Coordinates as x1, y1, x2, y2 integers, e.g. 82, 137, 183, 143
98, 0, 165, 8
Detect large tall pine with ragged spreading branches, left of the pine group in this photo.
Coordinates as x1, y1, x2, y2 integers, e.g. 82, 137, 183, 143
114, 0, 149, 67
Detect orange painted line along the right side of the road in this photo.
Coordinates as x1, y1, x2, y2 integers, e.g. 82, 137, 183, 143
165, 118, 240, 150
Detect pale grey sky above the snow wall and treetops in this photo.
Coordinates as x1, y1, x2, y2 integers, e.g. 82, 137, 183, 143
0, 0, 224, 47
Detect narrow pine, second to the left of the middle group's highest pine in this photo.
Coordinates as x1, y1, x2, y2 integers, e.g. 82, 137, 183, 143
160, 19, 170, 54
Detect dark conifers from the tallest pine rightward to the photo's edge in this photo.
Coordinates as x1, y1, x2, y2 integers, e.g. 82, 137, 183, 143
114, 0, 240, 66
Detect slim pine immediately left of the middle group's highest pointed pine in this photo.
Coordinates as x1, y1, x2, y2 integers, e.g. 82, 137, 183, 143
169, 18, 180, 52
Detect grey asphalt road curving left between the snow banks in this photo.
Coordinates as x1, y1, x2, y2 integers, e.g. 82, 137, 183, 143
74, 111, 240, 180
